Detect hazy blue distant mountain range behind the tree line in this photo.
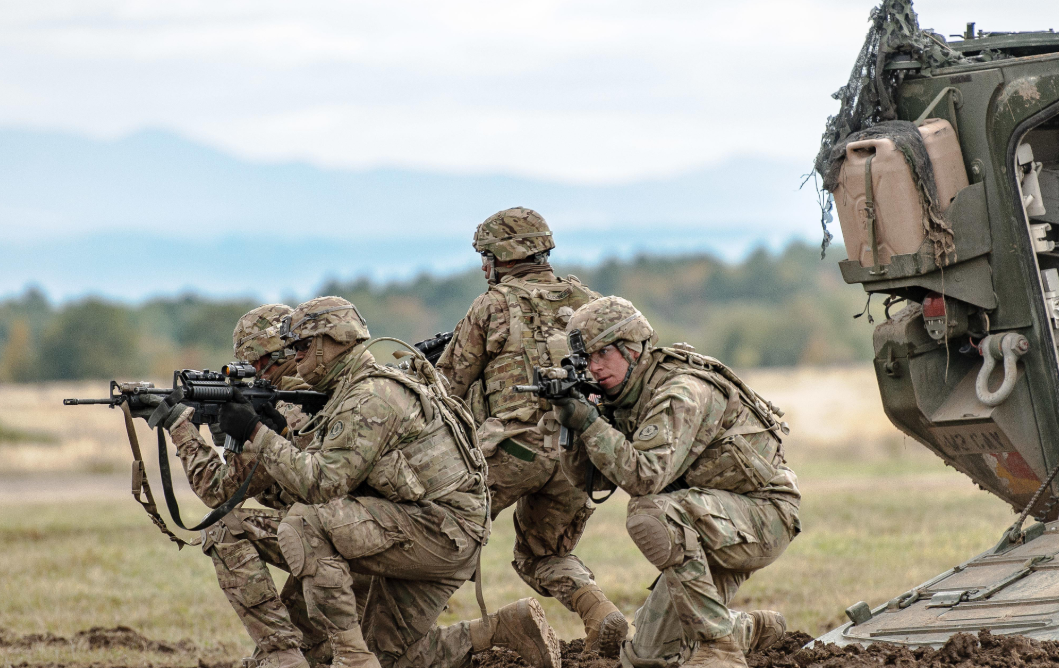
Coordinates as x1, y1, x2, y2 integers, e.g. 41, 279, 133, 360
0, 129, 819, 299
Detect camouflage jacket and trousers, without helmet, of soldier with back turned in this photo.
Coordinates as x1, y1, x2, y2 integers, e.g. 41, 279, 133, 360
437, 265, 598, 611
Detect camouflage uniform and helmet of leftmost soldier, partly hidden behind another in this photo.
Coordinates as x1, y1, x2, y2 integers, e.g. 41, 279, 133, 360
169, 304, 338, 654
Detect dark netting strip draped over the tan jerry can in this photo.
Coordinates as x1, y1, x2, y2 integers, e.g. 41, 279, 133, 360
823, 121, 956, 267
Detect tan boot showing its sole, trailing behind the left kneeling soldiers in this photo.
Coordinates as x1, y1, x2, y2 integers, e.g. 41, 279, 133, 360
470, 598, 561, 668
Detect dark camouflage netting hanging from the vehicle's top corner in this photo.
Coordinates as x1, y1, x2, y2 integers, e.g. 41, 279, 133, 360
813, 0, 967, 254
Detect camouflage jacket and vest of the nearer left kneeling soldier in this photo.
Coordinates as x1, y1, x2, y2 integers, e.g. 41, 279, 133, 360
252, 346, 488, 531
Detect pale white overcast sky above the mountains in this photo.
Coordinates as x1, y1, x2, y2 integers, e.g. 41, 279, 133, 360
0, 0, 1059, 182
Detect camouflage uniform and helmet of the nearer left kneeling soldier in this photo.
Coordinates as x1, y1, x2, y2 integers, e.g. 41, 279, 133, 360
247, 297, 489, 666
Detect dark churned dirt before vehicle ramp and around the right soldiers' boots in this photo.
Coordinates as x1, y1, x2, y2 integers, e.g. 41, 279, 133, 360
473, 631, 1059, 668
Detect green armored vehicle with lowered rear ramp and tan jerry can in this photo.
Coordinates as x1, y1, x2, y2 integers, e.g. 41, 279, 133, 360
816, 0, 1059, 646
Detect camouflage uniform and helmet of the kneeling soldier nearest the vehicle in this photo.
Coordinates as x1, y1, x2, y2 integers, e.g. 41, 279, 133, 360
562, 297, 801, 666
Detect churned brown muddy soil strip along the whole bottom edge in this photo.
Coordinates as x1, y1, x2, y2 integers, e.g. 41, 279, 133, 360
6, 627, 1059, 668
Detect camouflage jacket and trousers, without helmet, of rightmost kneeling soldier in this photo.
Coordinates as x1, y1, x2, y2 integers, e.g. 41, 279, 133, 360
561, 349, 801, 666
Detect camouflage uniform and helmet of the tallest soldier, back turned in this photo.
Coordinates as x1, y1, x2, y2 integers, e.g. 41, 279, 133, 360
437, 209, 624, 649
